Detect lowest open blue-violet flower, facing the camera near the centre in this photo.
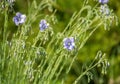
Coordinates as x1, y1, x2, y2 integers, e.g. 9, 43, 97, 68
63, 37, 75, 50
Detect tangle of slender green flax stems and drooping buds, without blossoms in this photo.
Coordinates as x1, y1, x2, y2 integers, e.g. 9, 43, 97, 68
0, 0, 118, 84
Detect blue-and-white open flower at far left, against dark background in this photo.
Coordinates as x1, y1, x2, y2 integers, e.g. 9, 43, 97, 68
13, 12, 26, 26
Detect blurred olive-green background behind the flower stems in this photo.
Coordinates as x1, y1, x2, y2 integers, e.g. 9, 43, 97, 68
0, 0, 120, 84
